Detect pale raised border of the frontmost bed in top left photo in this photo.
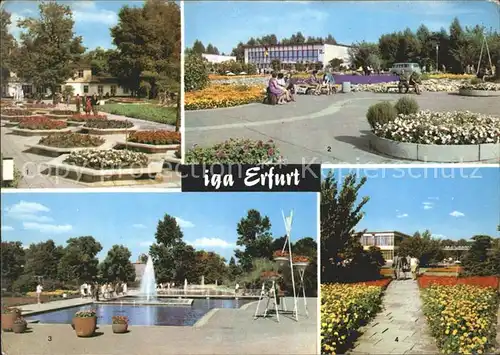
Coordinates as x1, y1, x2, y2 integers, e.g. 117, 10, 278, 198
45, 155, 163, 183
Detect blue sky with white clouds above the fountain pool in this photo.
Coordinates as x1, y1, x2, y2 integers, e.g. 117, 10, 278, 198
1, 192, 319, 261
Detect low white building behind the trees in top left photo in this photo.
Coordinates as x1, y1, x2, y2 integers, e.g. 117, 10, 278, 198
2, 67, 130, 97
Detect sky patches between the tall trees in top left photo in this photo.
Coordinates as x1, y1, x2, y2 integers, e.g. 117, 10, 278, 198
2, 0, 143, 50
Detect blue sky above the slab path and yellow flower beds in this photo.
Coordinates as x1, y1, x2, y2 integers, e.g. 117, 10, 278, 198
322, 168, 500, 240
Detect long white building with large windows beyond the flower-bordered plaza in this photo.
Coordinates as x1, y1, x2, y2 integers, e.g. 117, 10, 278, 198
245, 43, 349, 69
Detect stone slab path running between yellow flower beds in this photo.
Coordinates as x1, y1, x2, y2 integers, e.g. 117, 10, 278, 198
350, 280, 439, 354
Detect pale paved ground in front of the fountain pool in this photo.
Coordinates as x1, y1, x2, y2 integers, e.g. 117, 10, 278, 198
2, 298, 318, 355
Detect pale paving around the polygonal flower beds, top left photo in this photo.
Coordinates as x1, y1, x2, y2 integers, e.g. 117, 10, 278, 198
1, 105, 180, 188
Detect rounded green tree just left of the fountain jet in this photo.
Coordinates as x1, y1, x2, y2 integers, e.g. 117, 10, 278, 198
99, 245, 135, 282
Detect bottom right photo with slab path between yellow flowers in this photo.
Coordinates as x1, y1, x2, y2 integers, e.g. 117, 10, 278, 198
320, 166, 500, 354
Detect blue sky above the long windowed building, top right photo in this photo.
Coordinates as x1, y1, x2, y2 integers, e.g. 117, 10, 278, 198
184, 0, 500, 54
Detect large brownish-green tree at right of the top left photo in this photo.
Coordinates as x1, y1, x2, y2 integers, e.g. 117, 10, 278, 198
109, 0, 181, 98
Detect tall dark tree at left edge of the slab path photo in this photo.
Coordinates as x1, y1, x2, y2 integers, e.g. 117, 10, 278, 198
320, 171, 369, 283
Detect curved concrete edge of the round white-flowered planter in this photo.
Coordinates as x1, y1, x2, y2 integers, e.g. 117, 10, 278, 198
370, 133, 500, 163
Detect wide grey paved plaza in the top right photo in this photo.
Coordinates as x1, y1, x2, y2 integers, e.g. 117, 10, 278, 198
185, 92, 500, 164
